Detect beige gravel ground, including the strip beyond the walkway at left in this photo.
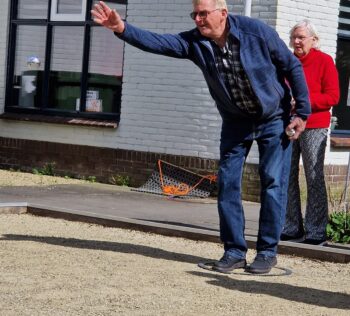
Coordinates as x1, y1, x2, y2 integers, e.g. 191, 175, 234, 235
0, 170, 350, 316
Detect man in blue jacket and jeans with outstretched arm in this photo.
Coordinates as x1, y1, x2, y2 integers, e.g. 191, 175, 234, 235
91, 0, 310, 273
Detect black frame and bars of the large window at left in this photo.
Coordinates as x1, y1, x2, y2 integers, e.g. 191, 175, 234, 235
5, 0, 127, 122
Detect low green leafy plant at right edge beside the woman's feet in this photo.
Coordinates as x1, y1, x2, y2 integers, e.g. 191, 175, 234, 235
326, 211, 350, 244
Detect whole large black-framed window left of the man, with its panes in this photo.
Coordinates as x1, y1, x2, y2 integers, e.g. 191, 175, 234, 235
5, 0, 127, 121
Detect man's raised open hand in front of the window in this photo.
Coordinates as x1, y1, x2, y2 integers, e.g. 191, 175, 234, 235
91, 1, 125, 33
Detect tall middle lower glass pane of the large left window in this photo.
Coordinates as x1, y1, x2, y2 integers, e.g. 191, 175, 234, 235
48, 26, 84, 111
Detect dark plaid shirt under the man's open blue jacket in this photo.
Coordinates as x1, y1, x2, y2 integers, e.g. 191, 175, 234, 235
212, 36, 260, 116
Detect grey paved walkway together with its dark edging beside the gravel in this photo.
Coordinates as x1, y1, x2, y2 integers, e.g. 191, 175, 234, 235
0, 183, 350, 262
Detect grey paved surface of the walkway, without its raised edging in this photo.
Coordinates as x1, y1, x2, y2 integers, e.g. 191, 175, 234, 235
0, 183, 260, 236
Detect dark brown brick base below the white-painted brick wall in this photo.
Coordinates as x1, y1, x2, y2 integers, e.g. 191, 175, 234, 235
0, 137, 347, 202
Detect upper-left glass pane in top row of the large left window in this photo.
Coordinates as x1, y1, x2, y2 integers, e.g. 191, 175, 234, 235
17, 0, 49, 19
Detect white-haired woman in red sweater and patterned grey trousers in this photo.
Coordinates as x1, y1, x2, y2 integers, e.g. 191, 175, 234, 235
281, 20, 339, 245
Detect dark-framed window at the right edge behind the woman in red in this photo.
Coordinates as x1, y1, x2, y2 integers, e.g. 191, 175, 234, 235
332, 0, 350, 134
